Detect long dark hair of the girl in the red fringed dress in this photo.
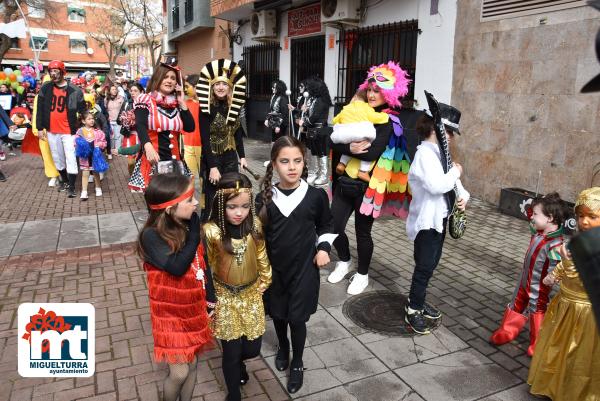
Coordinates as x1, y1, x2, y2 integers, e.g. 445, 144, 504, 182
137, 173, 190, 259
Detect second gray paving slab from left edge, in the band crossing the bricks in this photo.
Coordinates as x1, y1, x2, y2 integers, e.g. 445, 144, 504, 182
11, 220, 60, 255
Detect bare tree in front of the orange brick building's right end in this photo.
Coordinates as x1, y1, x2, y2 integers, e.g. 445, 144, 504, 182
88, 7, 134, 79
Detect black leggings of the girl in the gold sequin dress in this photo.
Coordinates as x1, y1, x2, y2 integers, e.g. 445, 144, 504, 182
221, 336, 262, 401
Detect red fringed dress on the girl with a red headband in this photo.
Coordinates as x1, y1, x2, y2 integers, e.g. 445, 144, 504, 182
144, 244, 212, 363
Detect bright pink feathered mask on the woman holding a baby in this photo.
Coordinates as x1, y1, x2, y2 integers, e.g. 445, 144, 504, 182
359, 61, 411, 107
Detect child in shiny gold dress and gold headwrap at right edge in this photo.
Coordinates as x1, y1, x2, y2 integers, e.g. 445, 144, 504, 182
527, 187, 600, 401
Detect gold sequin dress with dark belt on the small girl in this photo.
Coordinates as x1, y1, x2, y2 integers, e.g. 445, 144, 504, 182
204, 219, 271, 340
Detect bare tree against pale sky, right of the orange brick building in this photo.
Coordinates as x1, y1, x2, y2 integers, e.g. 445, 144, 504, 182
119, 0, 164, 67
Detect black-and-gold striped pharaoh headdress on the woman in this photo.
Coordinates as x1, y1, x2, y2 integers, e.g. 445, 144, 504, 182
196, 58, 246, 123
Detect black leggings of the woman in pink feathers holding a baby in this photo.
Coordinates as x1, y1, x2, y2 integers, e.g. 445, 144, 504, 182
331, 186, 374, 274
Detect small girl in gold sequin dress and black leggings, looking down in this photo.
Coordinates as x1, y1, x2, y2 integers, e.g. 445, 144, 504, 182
204, 173, 271, 401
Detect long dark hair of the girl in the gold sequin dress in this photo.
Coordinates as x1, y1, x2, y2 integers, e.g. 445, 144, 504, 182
209, 172, 262, 255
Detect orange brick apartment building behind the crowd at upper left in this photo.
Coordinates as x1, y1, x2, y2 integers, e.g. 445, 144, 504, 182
2, 0, 125, 73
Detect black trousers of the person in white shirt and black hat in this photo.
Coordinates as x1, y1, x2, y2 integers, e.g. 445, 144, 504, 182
408, 219, 448, 310
